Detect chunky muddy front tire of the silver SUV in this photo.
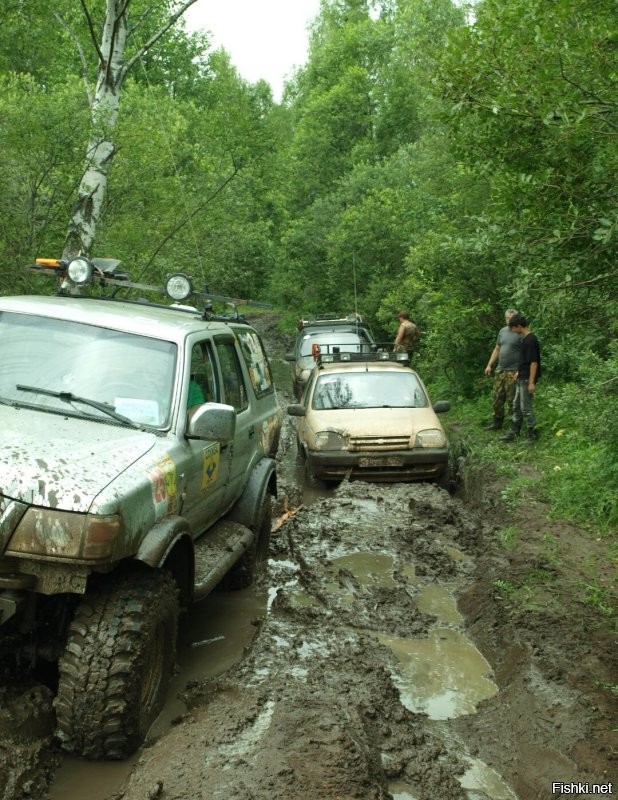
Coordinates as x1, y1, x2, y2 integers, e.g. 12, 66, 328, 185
54, 571, 178, 759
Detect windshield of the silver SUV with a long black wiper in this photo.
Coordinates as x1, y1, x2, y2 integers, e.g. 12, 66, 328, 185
0, 312, 176, 427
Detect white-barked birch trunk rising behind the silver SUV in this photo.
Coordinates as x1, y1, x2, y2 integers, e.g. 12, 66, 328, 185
63, 0, 196, 258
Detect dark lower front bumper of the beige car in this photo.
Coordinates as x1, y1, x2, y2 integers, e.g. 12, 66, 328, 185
307, 447, 448, 481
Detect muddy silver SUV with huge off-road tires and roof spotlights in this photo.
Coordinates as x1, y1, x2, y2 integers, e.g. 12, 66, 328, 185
0, 259, 281, 758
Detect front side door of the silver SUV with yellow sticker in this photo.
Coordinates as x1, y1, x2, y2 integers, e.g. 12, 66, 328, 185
182, 339, 232, 536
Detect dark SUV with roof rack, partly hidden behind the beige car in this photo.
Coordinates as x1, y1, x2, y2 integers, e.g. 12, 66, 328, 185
285, 314, 375, 400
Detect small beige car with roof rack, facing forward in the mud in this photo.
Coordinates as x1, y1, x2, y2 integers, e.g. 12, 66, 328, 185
288, 351, 450, 482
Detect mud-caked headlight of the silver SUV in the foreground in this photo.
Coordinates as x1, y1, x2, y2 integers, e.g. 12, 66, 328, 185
6, 508, 122, 560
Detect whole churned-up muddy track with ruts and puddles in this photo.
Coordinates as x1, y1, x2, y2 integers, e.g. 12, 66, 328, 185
0, 316, 618, 800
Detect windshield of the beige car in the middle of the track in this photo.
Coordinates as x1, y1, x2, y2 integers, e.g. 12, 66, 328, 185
312, 372, 429, 410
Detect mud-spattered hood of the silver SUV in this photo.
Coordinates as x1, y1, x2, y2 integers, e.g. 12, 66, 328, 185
0, 407, 157, 512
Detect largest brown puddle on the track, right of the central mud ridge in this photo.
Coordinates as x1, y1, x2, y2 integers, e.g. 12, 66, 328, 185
378, 628, 498, 719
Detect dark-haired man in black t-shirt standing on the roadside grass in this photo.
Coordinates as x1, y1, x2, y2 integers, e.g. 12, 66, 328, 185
500, 314, 541, 444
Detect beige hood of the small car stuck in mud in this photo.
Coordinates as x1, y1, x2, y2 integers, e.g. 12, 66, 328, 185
307, 407, 442, 437
